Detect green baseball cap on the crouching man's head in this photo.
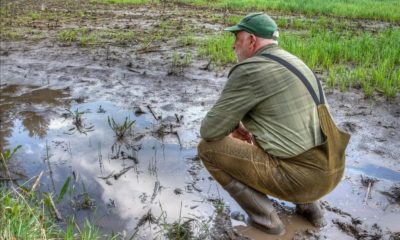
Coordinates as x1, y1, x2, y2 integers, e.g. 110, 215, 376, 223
224, 12, 278, 39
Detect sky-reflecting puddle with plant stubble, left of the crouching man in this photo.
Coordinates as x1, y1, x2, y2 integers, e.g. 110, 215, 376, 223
1, 92, 213, 234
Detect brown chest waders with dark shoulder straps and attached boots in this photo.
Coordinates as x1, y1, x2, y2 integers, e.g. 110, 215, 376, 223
198, 54, 350, 234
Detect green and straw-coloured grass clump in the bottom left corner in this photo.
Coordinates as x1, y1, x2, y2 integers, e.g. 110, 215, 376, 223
0, 145, 100, 240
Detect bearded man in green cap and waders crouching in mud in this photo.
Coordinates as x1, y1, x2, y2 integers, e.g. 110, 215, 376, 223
198, 13, 349, 234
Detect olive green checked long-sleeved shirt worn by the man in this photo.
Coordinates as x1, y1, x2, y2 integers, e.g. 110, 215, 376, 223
200, 44, 322, 157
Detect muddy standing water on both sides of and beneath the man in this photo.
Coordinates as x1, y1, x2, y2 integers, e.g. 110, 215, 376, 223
1, 85, 400, 239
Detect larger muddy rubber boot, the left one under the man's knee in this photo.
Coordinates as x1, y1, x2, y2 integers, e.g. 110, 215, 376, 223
224, 179, 285, 235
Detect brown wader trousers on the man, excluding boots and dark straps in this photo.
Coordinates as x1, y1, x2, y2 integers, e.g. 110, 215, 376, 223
198, 104, 350, 203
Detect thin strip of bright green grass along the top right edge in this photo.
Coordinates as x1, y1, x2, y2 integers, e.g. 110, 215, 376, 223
178, 0, 400, 22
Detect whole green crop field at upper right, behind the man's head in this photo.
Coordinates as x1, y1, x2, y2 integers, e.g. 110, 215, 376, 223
97, 0, 400, 99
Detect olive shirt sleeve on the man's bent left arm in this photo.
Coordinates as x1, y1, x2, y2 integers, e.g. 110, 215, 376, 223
200, 65, 256, 141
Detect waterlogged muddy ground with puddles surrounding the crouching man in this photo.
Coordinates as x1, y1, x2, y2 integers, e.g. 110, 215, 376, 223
0, 1, 400, 239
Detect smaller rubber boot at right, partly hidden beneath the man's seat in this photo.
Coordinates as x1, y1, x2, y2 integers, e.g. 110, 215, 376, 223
296, 201, 326, 228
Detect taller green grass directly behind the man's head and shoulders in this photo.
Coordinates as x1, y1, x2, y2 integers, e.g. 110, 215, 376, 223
198, 24, 400, 98
